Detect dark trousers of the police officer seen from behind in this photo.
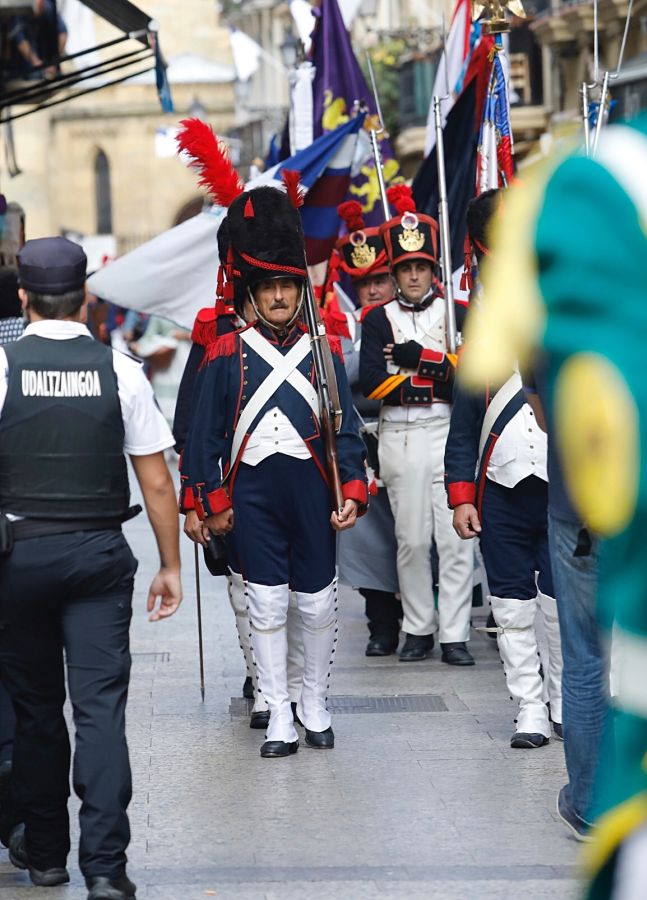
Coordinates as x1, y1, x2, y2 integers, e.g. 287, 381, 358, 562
0, 531, 137, 878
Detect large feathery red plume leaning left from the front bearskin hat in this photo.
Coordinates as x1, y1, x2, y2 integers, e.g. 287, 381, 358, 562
176, 119, 243, 206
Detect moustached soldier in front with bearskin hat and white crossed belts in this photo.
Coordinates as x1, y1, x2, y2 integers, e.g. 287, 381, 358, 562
184, 179, 367, 757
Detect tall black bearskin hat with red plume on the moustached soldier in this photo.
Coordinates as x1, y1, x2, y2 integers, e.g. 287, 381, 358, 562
177, 119, 307, 315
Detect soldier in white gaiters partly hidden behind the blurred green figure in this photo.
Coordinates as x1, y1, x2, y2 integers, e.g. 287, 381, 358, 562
445, 191, 562, 749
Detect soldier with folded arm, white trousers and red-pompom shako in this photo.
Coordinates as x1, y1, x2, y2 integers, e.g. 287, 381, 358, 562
360, 185, 474, 666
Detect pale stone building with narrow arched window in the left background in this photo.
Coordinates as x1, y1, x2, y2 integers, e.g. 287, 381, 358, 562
2, 0, 235, 253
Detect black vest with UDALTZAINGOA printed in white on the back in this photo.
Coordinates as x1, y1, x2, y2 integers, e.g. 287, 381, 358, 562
0, 335, 130, 521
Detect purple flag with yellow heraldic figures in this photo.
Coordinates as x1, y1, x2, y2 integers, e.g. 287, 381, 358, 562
310, 0, 399, 226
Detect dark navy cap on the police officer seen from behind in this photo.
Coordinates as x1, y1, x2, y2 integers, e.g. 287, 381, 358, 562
18, 237, 88, 294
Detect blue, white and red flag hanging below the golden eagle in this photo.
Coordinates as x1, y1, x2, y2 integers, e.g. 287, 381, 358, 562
476, 35, 514, 194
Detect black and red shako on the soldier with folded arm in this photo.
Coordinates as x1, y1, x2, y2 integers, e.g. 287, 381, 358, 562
380, 184, 438, 267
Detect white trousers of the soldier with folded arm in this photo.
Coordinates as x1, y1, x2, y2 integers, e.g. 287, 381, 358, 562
379, 418, 474, 644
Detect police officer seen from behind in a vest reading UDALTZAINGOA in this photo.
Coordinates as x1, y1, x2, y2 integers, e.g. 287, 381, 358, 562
0, 238, 182, 900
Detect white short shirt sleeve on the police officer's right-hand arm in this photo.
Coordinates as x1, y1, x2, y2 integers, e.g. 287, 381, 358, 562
112, 350, 175, 456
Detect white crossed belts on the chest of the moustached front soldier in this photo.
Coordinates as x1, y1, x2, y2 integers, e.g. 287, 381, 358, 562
230, 328, 320, 471
